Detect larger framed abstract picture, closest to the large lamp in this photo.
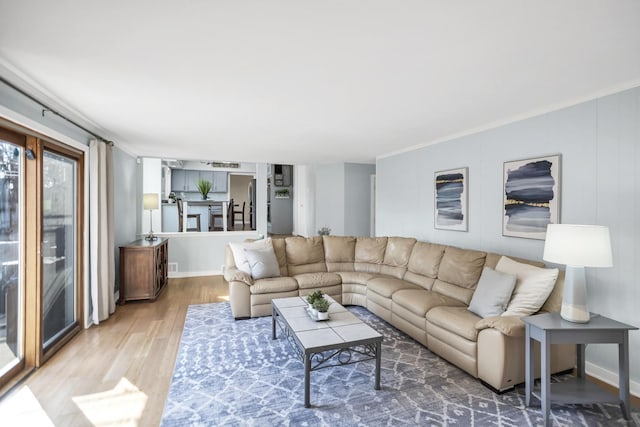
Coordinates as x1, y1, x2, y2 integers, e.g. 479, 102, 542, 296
502, 154, 561, 240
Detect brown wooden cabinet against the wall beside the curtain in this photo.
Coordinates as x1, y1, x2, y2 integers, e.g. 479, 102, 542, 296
120, 237, 169, 304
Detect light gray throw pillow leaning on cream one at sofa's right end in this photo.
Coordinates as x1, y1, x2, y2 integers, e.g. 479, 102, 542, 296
469, 267, 516, 318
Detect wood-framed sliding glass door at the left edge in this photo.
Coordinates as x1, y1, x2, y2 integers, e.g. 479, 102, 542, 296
0, 120, 84, 392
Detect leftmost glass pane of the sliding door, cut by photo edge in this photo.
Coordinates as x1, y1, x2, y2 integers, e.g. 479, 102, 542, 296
0, 139, 23, 377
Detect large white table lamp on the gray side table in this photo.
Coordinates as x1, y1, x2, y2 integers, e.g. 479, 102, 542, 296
542, 224, 613, 323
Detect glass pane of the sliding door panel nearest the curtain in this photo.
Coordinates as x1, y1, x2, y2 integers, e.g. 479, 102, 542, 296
42, 151, 77, 351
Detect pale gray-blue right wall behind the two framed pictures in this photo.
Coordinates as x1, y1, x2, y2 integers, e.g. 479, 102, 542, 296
376, 88, 640, 395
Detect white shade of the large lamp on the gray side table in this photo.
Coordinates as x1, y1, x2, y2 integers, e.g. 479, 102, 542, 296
542, 224, 613, 267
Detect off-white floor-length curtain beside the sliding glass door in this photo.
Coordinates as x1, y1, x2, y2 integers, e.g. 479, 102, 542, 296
89, 140, 116, 325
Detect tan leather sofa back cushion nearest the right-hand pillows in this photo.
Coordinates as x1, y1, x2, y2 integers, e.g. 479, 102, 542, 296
433, 246, 487, 304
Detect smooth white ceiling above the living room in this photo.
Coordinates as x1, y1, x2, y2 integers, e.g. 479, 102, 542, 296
0, 0, 640, 164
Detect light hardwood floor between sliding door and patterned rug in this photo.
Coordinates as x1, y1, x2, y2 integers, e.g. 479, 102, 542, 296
0, 276, 229, 426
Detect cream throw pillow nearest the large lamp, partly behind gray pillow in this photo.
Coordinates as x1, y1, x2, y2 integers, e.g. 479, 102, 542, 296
496, 256, 558, 317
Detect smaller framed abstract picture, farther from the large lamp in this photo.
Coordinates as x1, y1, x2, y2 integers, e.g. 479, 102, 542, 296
434, 168, 469, 231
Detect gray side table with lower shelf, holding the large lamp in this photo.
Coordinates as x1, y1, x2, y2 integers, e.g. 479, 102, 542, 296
522, 313, 638, 425
